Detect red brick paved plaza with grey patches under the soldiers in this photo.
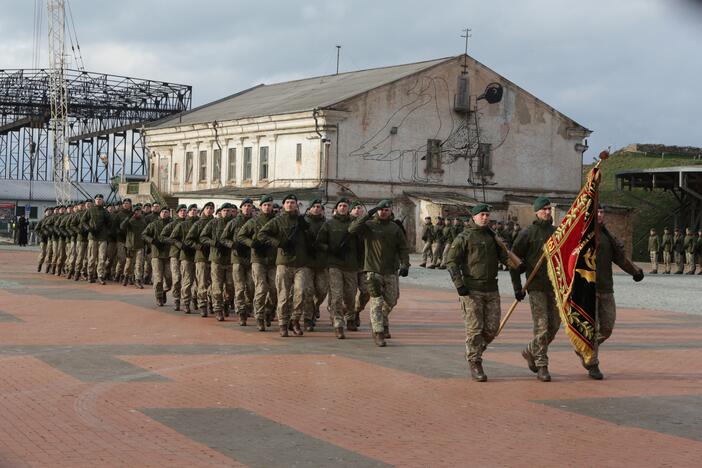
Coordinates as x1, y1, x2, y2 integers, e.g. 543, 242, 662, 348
0, 250, 702, 467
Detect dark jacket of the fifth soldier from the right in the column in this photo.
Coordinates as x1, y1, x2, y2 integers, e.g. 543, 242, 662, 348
257, 212, 311, 267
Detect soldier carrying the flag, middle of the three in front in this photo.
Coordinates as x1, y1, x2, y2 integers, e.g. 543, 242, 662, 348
510, 197, 561, 382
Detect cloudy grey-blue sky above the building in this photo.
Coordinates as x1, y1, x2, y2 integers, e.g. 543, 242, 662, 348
0, 0, 702, 159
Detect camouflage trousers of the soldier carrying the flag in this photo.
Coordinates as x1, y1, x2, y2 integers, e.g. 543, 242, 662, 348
527, 291, 561, 367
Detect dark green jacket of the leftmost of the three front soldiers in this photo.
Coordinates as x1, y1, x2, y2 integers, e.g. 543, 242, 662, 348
446, 220, 507, 292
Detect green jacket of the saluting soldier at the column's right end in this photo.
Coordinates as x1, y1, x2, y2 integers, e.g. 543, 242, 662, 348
349, 213, 409, 275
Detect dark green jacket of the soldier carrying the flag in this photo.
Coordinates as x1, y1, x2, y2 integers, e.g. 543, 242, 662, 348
510, 219, 556, 291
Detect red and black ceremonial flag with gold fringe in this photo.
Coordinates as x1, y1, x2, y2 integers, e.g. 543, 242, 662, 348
544, 152, 607, 365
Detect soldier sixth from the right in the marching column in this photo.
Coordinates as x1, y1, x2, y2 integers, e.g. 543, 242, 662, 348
236, 195, 278, 331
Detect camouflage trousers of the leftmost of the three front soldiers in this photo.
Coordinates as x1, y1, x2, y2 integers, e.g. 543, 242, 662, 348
459, 291, 501, 362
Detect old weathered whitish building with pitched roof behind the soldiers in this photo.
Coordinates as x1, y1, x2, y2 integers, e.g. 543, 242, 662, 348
147, 55, 590, 249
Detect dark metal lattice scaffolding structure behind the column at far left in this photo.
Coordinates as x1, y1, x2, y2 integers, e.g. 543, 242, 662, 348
0, 69, 192, 186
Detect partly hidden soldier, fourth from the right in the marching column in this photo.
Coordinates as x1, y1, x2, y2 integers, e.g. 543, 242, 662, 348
305, 199, 329, 331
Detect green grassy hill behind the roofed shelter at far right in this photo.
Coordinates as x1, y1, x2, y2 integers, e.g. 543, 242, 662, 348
583, 151, 702, 261
